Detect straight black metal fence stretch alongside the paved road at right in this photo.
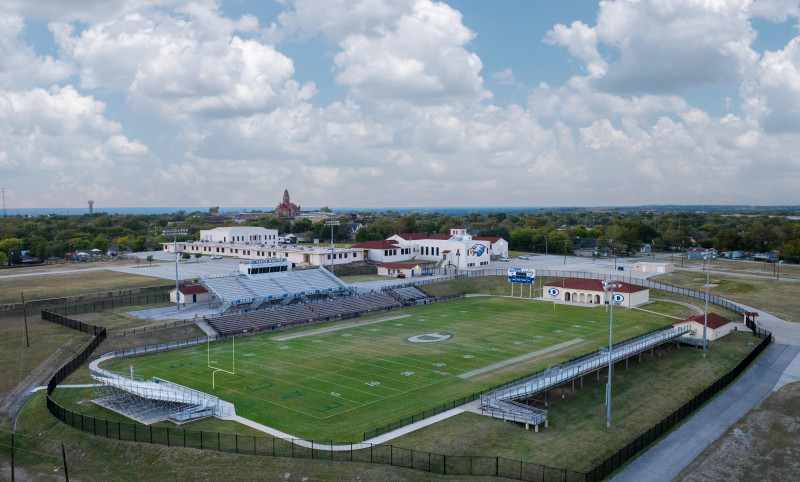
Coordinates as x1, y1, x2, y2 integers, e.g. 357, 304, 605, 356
586, 330, 772, 482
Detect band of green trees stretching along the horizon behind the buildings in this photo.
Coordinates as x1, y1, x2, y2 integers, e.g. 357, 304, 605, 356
0, 208, 800, 265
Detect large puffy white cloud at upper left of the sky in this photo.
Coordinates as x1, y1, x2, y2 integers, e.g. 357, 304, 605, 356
49, 4, 306, 118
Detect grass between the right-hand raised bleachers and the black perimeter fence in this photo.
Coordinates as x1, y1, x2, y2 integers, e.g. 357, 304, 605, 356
393, 332, 758, 471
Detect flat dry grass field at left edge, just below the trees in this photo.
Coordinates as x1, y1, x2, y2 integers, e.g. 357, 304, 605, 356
0, 270, 169, 304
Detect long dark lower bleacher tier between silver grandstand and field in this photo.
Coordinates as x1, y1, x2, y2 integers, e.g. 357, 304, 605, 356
206, 293, 401, 336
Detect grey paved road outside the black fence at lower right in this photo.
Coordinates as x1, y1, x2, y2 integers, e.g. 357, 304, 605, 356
614, 344, 800, 482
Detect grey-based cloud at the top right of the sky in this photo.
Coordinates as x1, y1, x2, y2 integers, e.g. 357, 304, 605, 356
545, 0, 758, 94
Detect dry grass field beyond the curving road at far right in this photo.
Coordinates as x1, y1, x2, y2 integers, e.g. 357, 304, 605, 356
651, 271, 800, 321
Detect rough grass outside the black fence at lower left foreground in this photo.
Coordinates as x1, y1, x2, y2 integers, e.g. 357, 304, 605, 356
6, 392, 482, 482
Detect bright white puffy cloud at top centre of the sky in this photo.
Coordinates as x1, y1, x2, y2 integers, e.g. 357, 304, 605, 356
280, 0, 491, 104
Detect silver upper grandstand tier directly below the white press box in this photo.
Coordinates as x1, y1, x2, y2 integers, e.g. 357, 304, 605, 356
200, 260, 351, 313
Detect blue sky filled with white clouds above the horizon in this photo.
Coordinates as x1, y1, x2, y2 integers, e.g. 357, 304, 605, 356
0, 0, 800, 209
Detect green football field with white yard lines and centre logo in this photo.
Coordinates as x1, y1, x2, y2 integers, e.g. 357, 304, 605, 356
101, 297, 674, 441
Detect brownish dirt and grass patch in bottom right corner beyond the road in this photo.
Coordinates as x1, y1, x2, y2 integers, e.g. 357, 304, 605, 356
676, 383, 800, 481
